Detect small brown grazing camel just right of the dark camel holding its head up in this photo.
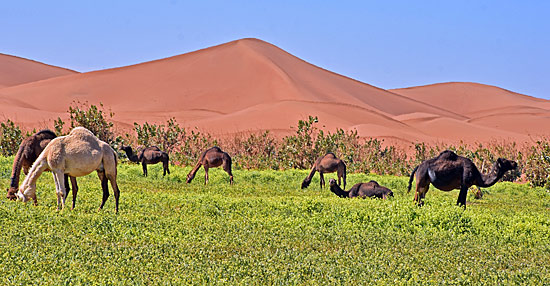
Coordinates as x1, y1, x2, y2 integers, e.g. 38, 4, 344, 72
187, 146, 233, 185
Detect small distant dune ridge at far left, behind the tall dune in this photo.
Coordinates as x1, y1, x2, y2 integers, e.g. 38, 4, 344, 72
0, 53, 78, 88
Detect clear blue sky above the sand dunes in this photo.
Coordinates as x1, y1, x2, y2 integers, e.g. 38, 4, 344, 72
0, 0, 550, 99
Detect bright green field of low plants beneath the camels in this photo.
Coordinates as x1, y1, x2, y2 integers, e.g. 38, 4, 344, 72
0, 155, 550, 285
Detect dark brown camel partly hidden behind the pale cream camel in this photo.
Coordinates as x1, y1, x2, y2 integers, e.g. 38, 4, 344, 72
7, 129, 78, 208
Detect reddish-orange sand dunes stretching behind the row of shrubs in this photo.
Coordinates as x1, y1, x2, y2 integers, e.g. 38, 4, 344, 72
0, 39, 550, 149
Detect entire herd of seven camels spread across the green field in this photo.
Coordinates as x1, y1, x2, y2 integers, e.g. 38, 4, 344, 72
7, 127, 517, 212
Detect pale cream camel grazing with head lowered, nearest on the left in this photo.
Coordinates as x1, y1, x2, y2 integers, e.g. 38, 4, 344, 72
17, 127, 120, 213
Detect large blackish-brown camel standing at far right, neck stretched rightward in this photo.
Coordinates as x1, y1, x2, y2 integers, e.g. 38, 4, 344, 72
408, 150, 518, 208
